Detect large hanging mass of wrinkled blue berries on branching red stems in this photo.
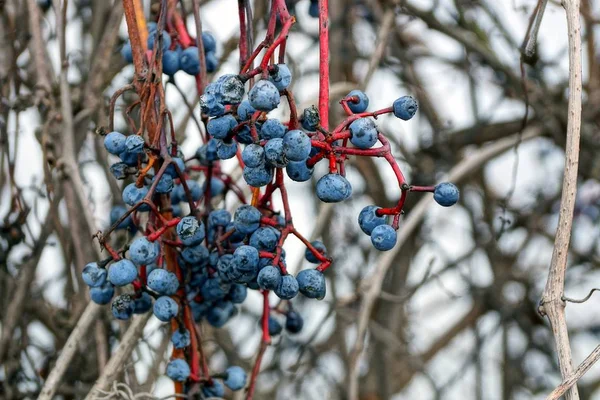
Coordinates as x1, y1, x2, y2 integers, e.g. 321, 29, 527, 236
90, 2, 459, 397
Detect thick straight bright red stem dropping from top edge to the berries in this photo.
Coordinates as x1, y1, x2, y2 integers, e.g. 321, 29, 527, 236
319, 0, 329, 130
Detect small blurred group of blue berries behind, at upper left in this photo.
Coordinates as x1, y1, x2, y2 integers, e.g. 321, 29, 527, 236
121, 22, 219, 76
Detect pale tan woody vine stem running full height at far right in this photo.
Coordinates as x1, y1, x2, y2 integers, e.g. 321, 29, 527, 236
539, 0, 582, 400
